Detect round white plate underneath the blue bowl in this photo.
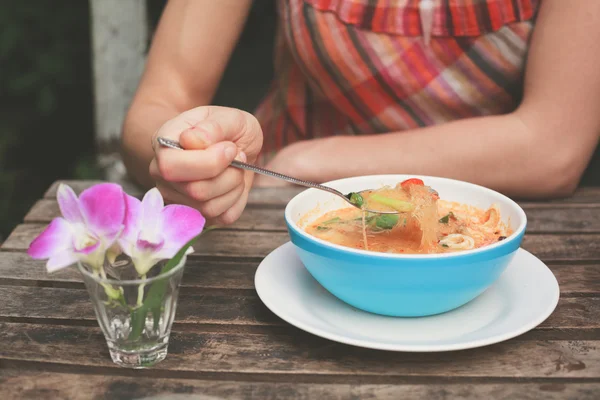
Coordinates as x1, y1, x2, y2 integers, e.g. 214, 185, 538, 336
254, 242, 560, 352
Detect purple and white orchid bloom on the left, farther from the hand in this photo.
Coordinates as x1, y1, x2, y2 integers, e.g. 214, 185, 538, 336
27, 183, 125, 272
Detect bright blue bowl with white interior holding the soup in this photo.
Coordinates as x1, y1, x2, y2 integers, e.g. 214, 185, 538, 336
285, 175, 527, 317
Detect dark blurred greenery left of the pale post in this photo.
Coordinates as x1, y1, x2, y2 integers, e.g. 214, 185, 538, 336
0, 0, 96, 242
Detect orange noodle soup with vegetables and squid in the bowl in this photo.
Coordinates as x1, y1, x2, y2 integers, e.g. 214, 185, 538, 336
306, 178, 512, 254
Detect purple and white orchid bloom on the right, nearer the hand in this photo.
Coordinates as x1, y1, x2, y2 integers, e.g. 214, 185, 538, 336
118, 188, 206, 276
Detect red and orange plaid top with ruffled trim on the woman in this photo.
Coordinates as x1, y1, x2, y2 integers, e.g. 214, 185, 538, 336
255, 0, 539, 163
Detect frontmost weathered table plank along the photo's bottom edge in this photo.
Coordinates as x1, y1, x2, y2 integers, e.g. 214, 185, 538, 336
0, 369, 600, 400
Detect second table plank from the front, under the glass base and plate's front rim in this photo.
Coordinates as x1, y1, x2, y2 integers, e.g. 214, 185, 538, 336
0, 323, 600, 383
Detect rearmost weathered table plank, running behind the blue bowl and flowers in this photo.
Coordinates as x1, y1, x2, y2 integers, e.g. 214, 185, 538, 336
44, 180, 600, 208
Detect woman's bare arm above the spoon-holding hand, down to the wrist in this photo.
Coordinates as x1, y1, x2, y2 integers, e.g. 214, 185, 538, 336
122, 0, 252, 186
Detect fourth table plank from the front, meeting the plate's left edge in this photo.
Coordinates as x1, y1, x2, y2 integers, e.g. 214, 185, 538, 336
0, 252, 600, 297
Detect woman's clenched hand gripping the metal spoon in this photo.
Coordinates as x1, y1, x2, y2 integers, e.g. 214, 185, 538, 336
149, 106, 263, 225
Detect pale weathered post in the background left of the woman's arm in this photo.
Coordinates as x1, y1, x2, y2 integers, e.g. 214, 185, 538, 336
90, 0, 149, 182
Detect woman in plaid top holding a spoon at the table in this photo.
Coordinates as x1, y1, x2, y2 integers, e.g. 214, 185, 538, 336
123, 0, 600, 224
